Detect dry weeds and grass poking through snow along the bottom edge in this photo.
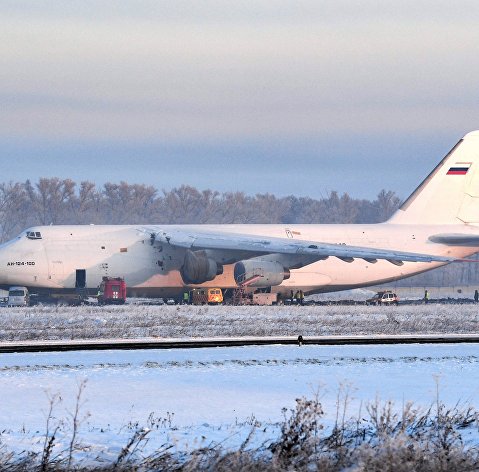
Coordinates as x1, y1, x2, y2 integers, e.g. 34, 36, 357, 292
0, 391, 479, 472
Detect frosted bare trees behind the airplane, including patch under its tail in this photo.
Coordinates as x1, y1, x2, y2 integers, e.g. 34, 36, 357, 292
0, 177, 479, 285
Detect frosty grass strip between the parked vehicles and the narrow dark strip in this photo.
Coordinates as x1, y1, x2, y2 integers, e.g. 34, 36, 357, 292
0, 304, 479, 342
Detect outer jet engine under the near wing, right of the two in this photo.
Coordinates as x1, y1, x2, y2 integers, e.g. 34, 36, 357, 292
234, 260, 290, 287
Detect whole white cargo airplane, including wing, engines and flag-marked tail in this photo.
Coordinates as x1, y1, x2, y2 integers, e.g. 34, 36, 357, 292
0, 131, 479, 297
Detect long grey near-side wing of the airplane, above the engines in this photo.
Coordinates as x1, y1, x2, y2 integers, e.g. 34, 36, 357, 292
151, 227, 458, 265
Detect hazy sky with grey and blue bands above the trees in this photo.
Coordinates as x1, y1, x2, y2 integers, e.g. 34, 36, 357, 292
0, 0, 479, 198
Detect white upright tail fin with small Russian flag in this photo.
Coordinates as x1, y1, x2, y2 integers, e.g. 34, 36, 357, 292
388, 131, 479, 224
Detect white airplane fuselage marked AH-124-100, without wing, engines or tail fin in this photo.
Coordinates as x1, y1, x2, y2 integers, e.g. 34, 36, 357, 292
0, 223, 479, 296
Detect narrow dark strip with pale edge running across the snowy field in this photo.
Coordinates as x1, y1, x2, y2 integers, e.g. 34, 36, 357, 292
0, 334, 479, 353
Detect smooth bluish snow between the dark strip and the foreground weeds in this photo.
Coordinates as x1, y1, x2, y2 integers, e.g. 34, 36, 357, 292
0, 344, 479, 456
